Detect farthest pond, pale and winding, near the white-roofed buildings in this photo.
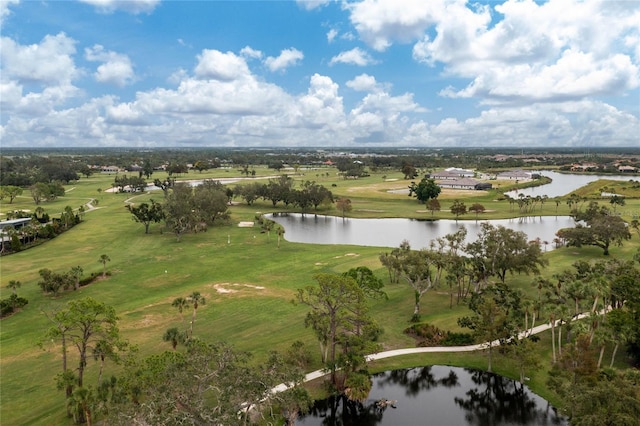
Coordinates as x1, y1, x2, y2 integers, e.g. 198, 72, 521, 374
505, 170, 640, 198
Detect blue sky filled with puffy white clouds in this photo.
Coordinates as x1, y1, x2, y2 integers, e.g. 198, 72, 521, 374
0, 0, 640, 147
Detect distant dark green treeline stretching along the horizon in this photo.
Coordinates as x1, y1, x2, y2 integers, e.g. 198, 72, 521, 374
0, 147, 640, 187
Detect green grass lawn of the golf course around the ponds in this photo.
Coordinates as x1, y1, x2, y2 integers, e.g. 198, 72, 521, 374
0, 168, 640, 425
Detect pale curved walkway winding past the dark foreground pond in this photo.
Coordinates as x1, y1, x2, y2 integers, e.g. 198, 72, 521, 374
271, 311, 602, 393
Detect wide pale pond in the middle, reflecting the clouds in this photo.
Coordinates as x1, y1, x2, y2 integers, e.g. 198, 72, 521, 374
268, 213, 575, 251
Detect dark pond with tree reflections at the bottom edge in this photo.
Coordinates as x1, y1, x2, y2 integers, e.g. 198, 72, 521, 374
296, 365, 568, 426
